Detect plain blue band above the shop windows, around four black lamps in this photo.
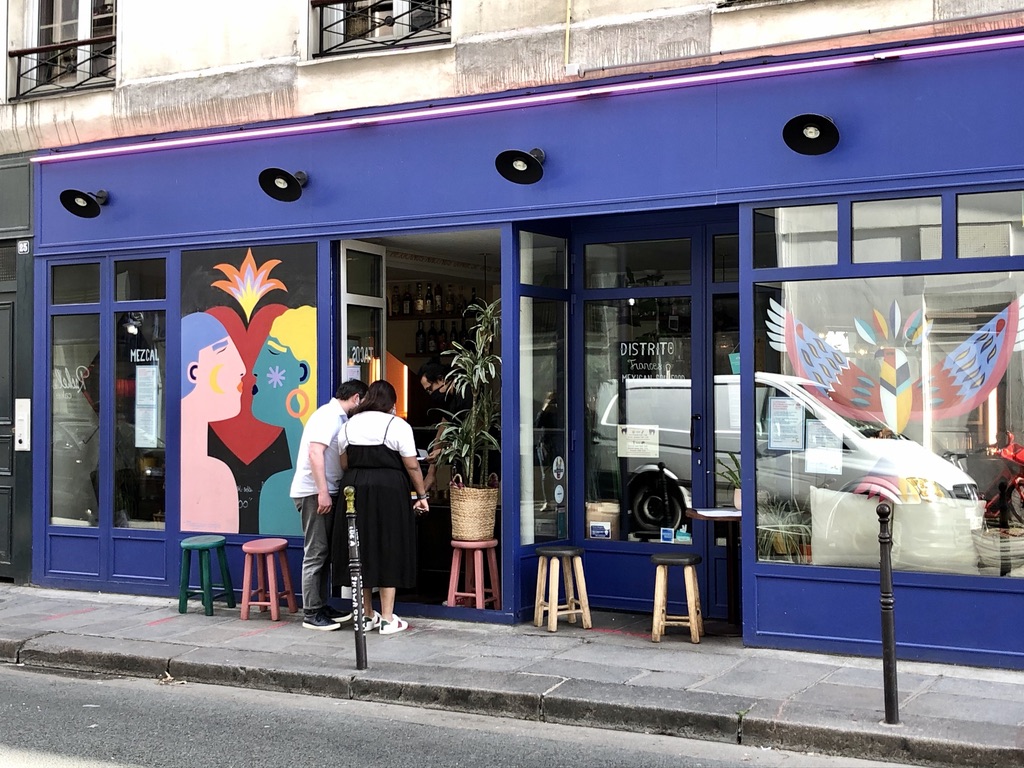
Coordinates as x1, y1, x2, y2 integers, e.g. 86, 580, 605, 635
37, 49, 1024, 253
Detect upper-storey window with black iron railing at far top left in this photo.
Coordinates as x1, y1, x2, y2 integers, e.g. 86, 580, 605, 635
8, 0, 117, 98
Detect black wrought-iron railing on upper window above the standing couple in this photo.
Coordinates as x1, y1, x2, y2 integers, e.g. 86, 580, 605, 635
310, 0, 452, 57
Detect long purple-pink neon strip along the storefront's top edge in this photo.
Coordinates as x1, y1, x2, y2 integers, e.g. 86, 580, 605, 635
29, 34, 1024, 163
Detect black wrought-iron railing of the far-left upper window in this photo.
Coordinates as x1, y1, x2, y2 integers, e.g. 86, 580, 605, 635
7, 35, 117, 98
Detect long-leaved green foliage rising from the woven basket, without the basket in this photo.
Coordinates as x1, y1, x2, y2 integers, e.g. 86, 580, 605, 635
431, 300, 502, 486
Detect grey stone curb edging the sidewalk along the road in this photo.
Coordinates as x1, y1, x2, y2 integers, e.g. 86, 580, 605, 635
8, 628, 1024, 768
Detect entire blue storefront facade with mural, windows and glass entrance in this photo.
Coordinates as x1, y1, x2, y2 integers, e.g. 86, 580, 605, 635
32, 35, 1024, 668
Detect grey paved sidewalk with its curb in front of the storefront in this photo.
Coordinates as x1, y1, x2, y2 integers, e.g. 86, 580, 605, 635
0, 585, 1024, 768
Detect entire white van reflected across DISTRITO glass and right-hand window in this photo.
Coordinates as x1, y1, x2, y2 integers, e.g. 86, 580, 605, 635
589, 373, 984, 572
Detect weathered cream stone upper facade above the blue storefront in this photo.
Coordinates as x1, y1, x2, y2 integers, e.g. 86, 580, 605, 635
8, 0, 1024, 156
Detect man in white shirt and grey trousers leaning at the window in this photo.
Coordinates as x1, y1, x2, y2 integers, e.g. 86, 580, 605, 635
291, 379, 367, 632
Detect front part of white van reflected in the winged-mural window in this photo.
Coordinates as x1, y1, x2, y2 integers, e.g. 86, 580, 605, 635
757, 374, 984, 573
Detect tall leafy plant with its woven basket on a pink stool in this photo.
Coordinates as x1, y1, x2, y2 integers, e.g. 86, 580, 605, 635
431, 300, 502, 541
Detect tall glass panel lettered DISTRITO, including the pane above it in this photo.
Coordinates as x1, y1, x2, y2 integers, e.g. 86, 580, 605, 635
582, 238, 702, 544
